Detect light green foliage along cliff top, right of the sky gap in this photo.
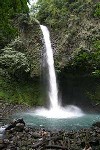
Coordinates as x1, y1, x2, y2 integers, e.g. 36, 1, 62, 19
31, 0, 100, 28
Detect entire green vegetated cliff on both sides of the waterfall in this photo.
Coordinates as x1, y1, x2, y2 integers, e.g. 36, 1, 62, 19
0, 0, 100, 105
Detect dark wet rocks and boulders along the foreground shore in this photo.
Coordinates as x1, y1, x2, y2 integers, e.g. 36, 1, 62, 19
0, 119, 100, 150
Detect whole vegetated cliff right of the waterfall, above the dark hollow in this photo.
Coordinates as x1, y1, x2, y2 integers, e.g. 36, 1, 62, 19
31, 0, 100, 75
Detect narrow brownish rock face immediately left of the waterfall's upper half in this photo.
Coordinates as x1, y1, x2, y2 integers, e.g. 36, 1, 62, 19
19, 17, 43, 76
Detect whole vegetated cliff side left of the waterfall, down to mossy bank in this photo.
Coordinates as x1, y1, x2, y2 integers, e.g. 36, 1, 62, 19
0, 0, 43, 106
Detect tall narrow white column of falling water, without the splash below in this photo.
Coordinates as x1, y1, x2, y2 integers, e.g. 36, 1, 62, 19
40, 25, 59, 109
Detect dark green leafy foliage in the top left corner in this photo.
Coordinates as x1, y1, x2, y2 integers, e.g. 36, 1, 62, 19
0, 0, 29, 48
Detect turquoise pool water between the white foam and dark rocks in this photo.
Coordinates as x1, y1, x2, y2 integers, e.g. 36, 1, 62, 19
14, 113, 100, 130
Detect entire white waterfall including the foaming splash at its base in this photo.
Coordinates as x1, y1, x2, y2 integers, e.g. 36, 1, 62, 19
35, 25, 83, 118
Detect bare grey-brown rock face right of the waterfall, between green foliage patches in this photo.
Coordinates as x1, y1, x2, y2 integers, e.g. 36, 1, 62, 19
51, 2, 100, 72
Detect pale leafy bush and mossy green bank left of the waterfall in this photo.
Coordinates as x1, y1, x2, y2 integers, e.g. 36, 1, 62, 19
0, 38, 44, 106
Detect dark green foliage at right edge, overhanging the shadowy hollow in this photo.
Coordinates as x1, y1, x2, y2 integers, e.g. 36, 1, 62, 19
64, 40, 100, 76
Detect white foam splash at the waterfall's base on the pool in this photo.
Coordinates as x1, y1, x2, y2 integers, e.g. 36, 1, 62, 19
29, 105, 84, 119
